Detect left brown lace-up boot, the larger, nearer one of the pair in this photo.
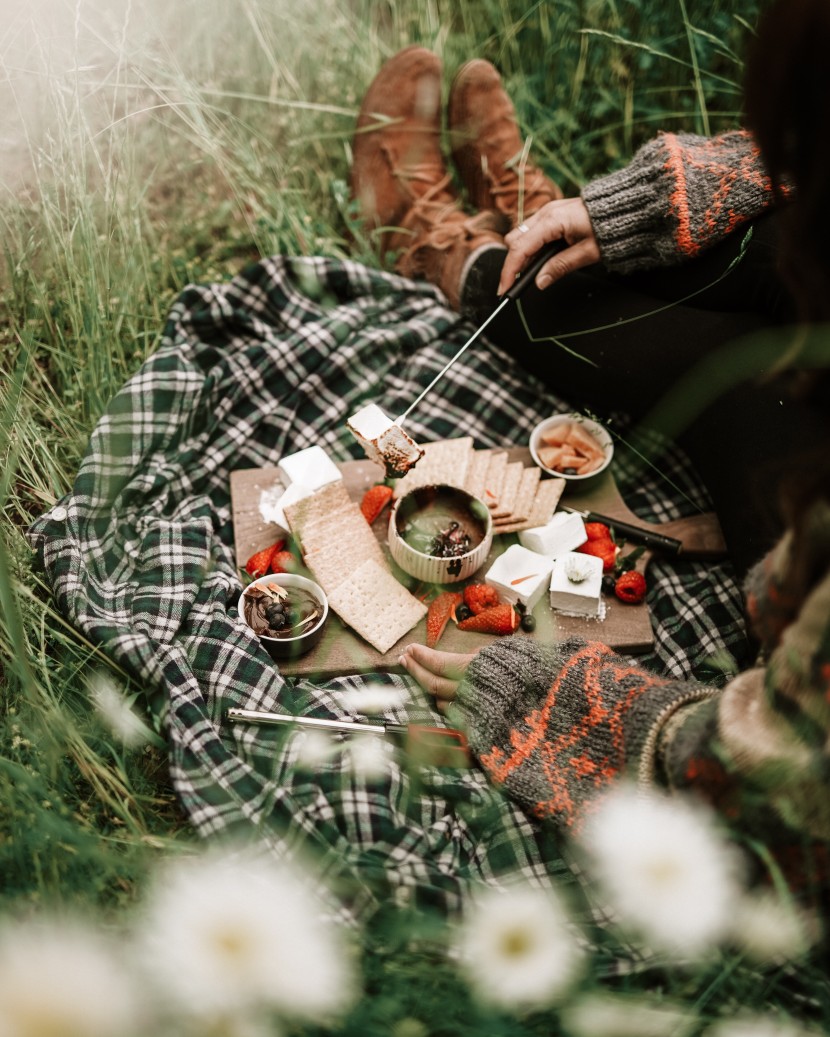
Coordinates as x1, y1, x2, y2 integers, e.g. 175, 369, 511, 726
351, 47, 504, 309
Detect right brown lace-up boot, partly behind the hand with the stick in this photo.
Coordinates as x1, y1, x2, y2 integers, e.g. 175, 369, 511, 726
448, 58, 562, 233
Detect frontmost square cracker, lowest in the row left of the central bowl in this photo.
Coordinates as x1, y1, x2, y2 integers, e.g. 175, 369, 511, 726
329, 559, 426, 654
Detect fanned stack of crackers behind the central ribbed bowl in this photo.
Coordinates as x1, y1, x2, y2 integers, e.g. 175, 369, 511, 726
394, 436, 565, 533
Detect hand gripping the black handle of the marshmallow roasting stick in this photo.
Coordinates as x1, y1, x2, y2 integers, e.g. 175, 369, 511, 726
499, 198, 600, 296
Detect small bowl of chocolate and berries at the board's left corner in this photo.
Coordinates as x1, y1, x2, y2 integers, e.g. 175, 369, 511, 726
239, 572, 329, 658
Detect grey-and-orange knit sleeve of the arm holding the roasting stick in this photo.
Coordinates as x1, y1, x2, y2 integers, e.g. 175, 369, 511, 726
582, 130, 774, 274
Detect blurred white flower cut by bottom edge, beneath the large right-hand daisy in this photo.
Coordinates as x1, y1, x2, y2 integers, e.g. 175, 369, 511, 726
562, 993, 699, 1037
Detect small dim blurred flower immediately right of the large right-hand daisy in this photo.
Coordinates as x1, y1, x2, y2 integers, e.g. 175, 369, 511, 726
732, 892, 815, 962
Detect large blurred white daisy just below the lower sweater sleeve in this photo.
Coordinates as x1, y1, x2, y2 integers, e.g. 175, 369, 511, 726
582, 786, 741, 958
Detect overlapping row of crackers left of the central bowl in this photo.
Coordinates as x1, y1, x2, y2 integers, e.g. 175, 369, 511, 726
285, 480, 426, 654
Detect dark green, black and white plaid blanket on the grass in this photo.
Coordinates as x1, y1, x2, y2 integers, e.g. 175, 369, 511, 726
29, 256, 743, 919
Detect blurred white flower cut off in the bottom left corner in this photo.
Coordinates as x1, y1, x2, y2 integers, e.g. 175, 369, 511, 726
0, 919, 141, 1037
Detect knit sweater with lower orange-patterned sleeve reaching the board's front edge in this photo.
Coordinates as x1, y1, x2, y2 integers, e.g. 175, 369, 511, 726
455, 503, 830, 892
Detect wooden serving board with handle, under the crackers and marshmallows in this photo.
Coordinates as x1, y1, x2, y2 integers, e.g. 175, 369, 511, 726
230, 447, 724, 678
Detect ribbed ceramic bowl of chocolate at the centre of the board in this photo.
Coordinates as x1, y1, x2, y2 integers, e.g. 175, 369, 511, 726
388, 485, 493, 584
